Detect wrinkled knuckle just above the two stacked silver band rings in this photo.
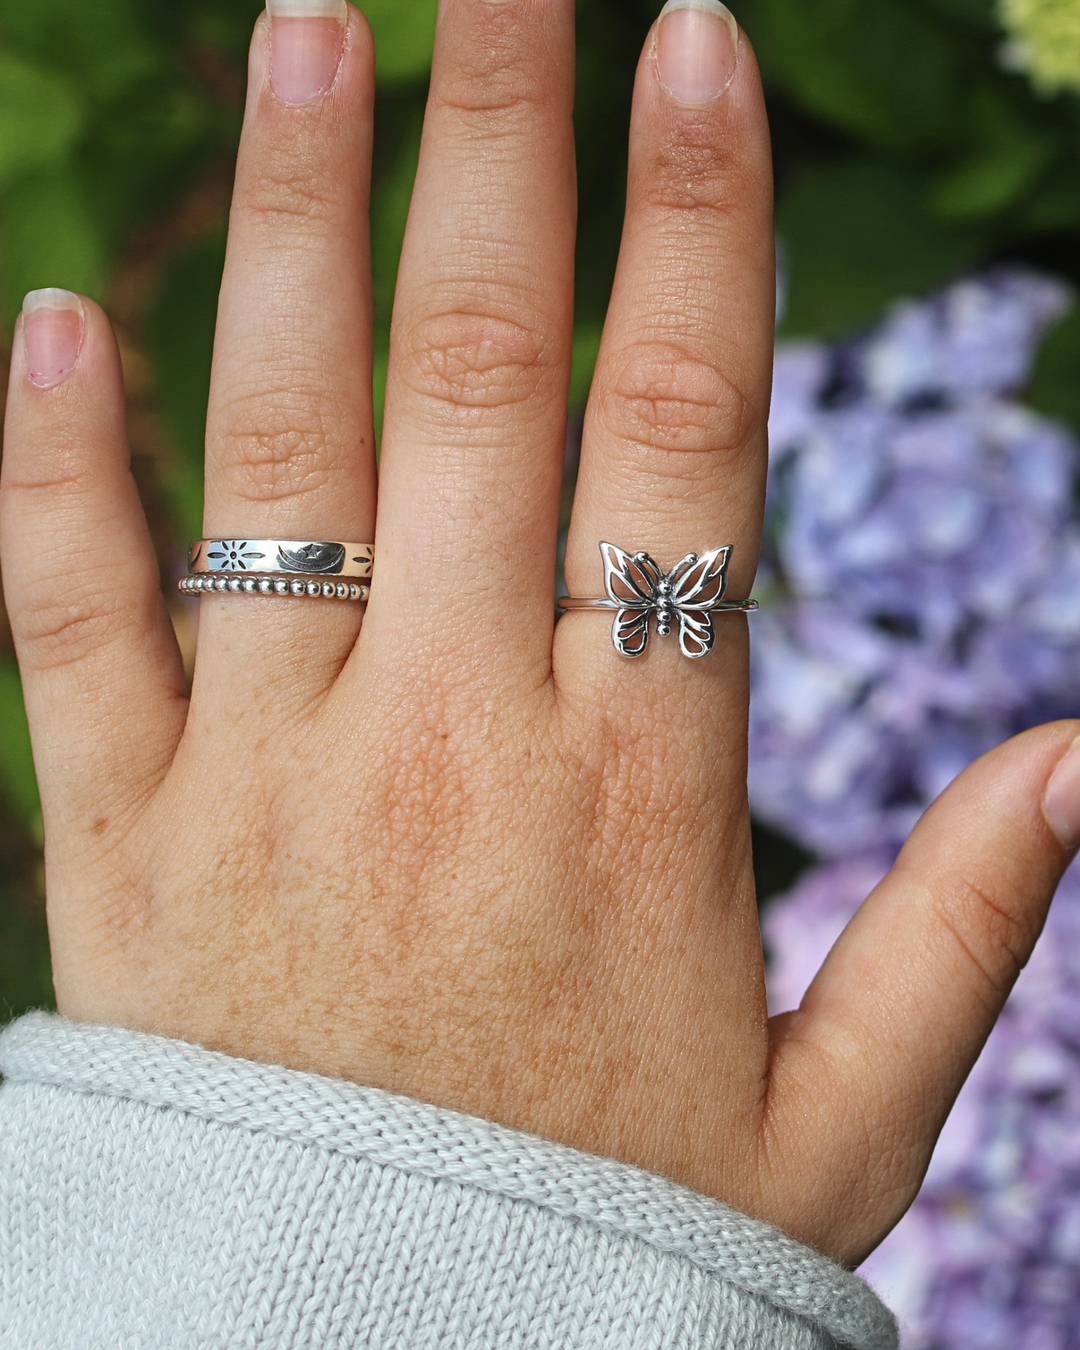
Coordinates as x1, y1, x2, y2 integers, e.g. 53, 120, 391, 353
217, 390, 365, 502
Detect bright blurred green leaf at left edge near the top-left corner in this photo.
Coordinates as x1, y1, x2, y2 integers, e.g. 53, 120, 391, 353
0, 50, 82, 185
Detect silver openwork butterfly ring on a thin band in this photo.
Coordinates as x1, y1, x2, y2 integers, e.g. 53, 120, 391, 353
559, 544, 757, 659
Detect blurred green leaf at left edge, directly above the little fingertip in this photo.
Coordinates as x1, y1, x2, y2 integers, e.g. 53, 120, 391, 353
0, 165, 107, 317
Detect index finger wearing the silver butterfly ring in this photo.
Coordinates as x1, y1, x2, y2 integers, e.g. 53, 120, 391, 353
556, 0, 774, 707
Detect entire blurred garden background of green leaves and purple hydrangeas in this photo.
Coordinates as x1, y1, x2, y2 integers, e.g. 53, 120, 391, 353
0, 0, 1080, 1350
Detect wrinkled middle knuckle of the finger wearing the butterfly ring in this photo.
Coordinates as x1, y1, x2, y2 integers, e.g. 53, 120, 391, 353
601, 342, 764, 454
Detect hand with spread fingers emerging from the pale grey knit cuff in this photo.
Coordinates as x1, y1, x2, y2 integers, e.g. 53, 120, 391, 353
1, 0, 1080, 1262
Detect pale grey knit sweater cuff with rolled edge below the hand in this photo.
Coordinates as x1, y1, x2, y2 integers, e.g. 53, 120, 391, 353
0, 1013, 896, 1350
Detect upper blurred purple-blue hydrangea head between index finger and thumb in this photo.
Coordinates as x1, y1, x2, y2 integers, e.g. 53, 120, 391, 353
749, 269, 1080, 856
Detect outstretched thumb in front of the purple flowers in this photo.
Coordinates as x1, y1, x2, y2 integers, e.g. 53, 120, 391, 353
767, 722, 1080, 1265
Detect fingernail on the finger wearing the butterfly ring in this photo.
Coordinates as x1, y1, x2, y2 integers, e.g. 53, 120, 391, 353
656, 0, 738, 107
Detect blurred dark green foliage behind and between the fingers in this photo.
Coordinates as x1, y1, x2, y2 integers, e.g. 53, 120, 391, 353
0, 0, 1080, 1019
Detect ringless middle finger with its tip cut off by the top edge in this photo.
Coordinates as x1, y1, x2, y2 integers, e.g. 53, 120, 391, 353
363, 0, 576, 680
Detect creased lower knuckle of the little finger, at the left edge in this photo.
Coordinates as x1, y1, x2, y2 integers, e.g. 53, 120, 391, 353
11, 579, 132, 671
